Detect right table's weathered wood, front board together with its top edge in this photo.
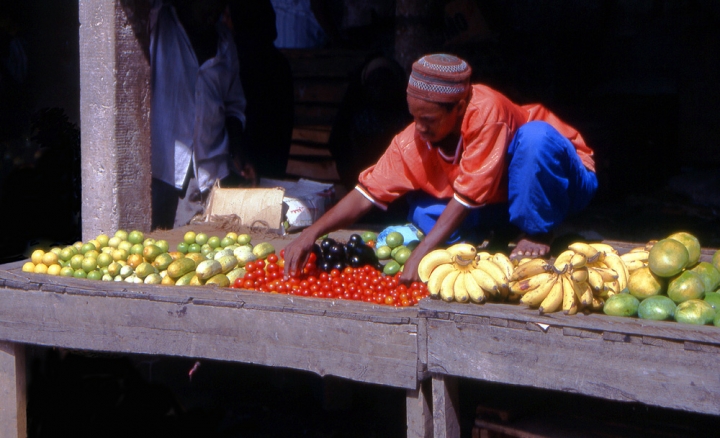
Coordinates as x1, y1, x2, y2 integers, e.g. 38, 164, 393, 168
420, 300, 720, 414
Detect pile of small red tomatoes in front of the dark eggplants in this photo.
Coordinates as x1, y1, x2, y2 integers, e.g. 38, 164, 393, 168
230, 254, 428, 307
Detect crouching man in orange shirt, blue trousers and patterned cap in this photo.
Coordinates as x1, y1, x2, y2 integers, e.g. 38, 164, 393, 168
285, 54, 597, 282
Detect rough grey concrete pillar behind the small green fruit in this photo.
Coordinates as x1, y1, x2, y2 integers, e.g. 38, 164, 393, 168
79, 0, 151, 241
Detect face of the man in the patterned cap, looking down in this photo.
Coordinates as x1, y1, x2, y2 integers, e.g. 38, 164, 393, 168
408, 96, 463, 144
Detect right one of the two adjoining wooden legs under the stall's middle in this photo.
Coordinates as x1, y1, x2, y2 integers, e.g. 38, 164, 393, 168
432, 374, 460, 438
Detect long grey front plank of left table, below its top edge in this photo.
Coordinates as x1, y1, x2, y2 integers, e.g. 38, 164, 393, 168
0, 289, 417, 388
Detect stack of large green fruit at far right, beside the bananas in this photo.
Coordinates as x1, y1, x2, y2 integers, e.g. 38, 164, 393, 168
604, 231, 720, 326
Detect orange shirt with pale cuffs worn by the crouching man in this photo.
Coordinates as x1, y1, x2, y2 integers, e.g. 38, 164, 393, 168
357, 85, 595, 208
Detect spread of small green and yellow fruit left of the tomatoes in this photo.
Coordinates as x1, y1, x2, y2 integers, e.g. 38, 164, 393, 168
22, 230, 275, 286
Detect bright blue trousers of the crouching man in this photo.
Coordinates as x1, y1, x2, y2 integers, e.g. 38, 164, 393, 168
407, 121, 598, 244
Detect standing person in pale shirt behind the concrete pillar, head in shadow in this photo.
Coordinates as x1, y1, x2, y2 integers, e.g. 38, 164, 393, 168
150, 0, 256, 228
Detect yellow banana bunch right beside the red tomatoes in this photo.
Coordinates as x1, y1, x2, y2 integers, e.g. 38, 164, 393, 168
418, 243, 514, 304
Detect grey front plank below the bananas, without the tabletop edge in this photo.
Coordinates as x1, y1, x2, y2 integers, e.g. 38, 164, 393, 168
427, 319, 720, 415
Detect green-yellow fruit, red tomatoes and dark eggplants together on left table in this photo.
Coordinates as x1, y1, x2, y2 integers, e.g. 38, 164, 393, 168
22, 230, 427, 307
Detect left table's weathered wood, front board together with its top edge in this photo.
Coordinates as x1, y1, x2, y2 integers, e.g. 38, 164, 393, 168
0, 265, 422, 389
